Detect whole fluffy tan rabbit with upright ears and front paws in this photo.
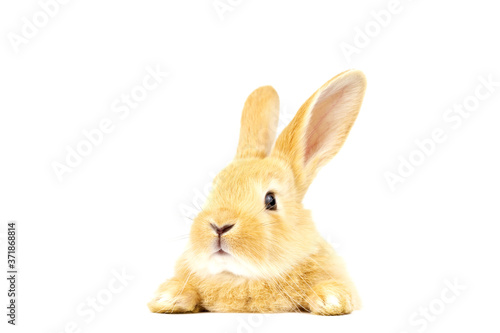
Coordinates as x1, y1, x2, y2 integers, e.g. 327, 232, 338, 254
148, 70, 366, 315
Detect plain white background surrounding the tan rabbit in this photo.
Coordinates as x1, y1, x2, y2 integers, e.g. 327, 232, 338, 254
0, 0, 500, 333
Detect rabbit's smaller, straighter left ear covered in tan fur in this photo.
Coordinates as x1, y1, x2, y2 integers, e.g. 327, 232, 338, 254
236, 86, 280, 158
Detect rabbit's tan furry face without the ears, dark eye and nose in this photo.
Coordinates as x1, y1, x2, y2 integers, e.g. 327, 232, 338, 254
186, 157, 314, 278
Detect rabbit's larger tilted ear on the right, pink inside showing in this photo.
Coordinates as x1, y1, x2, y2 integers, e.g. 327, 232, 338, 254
272, 70, 366, 199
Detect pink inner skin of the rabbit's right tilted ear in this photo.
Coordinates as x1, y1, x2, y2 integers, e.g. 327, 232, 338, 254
304, 86, 347, 164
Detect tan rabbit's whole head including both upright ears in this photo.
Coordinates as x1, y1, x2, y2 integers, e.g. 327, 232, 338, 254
185, 70, 366, 279
